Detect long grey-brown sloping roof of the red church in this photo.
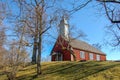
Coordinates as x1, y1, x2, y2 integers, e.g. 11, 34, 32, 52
70, 40, 106, 55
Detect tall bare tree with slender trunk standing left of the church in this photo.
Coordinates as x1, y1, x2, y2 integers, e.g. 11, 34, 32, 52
11, 0, 58, 75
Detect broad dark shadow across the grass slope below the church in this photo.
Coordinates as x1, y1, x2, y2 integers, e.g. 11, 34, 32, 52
44, 62, 120, 80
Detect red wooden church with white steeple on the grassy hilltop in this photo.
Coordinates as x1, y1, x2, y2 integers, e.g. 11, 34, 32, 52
51, 18, 106, 61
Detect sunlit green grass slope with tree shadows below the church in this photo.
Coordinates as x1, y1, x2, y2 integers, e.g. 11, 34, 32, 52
0, 61, 120, 80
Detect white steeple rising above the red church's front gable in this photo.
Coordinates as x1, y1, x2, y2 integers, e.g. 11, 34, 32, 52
59, 17, 69, 39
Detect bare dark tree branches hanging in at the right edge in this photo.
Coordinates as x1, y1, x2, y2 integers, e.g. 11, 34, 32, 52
97, 0, 120, 47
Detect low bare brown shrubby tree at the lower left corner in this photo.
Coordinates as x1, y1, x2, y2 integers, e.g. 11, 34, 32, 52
3, 42, 28, 80
